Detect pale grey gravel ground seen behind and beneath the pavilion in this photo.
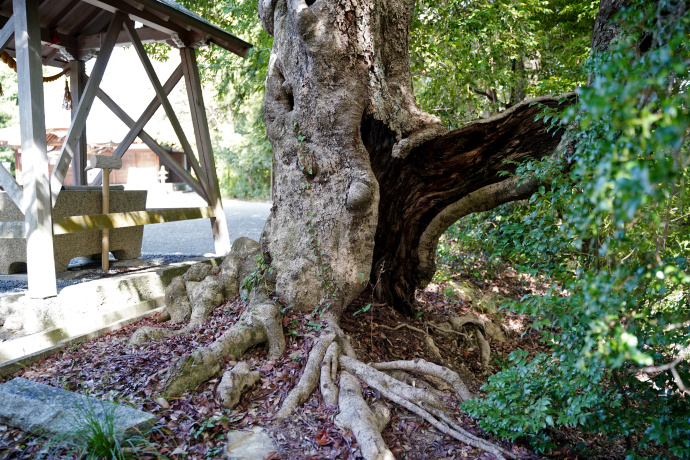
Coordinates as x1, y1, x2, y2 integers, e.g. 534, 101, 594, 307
0, 192, 271, 294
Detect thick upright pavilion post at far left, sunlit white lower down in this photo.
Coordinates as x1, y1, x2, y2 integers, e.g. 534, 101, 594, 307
12, 0, 57, 298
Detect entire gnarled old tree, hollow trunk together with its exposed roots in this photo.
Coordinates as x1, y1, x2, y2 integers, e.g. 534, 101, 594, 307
132, 0, 621, 460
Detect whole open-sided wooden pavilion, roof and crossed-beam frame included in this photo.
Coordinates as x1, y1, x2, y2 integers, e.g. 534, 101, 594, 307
0, 0, 251, 298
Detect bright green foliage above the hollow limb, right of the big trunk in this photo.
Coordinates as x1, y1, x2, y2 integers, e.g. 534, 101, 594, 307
410, 0, 599, 128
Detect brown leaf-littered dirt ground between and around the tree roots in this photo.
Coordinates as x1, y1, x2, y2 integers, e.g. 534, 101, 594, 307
0, 260, 622, 460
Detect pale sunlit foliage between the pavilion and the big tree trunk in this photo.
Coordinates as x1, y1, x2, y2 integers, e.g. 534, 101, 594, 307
168, 0, 273, 199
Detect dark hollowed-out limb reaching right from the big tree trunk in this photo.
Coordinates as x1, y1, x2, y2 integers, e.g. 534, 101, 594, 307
370, 93, 575, 314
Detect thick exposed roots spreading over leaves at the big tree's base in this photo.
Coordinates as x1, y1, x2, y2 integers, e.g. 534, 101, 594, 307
133, 259, 514, 460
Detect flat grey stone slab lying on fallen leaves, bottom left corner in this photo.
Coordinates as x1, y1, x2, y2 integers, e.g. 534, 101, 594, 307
0, 377, 156, 439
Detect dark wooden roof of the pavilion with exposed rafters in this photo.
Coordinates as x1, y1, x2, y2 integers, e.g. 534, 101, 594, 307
0, 0, 251, 68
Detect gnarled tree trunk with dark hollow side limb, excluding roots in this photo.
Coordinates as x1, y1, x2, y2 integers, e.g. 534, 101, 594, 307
259, 0, 560, 318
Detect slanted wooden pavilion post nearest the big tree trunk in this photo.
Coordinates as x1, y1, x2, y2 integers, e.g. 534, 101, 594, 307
180, 47, 230, 255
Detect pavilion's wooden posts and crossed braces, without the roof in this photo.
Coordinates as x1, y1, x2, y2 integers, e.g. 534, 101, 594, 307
0, 0, 230, 298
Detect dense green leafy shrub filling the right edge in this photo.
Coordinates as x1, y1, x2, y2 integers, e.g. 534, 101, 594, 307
458, 1, 690, 458
